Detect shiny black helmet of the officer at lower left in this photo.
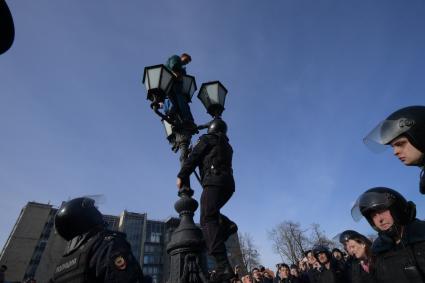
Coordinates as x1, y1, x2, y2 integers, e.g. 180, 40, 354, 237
55, 197, 104, 241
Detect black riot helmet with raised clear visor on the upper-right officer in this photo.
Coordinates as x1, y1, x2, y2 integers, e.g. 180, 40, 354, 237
363, 106, 425, 153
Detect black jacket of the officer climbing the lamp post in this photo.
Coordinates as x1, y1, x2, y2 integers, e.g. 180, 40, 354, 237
177, 133, 235, 190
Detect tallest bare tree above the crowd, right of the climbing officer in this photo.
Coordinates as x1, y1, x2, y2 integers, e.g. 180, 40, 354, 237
269, 221, 309, 263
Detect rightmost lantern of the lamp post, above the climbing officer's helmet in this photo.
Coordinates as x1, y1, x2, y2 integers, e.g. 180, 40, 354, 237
198, 81, 227, 116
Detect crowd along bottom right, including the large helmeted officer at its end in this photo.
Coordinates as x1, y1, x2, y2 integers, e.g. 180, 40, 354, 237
230, 187, 425, 283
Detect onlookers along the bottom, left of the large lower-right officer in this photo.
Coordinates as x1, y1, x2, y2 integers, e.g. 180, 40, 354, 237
230, 236, 374, 283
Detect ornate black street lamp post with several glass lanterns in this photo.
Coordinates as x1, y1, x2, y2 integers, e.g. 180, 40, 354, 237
143, 65, 227, 283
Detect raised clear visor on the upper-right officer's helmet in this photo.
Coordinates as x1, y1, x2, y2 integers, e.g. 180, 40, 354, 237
363, 118, 414, 152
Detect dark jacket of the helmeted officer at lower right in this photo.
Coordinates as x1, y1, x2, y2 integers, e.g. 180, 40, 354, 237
372, 219, 425, 283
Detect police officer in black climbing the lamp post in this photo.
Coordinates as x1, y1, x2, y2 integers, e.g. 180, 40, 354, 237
177, 118, 237, 282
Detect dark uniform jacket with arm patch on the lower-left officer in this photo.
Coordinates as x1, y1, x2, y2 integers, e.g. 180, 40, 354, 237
50, 228, 143, 283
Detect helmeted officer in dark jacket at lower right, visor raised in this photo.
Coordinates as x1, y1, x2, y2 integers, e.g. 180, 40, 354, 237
351, 187, 425, 283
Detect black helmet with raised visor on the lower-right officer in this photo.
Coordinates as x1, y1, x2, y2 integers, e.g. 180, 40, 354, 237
351, 187, 416, 232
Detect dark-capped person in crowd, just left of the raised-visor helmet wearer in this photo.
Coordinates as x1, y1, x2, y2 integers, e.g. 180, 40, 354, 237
313, 246, 345, 283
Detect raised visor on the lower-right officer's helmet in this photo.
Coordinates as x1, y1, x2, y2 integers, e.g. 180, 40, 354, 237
351, 192, 395, 222
